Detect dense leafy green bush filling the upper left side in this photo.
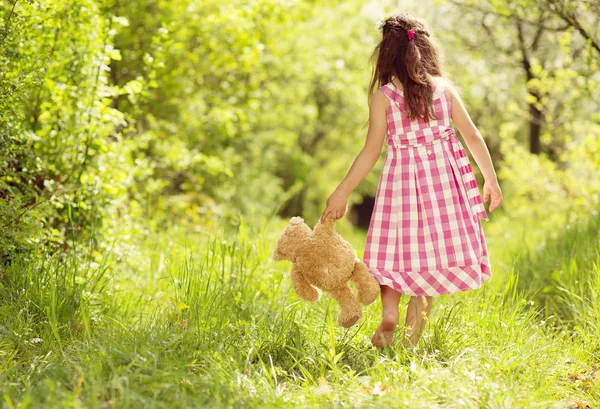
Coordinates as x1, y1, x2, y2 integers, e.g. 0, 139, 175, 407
0, 0, 132, 253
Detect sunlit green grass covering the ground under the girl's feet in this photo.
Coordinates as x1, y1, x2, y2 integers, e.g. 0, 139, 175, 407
0, 217, 600, 408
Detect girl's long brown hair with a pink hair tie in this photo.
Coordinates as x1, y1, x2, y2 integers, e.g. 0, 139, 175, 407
369, 13, 442, 121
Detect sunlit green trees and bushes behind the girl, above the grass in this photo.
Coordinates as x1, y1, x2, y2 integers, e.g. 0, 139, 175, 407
0, 0, 599, 247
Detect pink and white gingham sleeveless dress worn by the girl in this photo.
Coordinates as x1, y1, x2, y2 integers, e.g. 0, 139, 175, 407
363, 79, 492, 295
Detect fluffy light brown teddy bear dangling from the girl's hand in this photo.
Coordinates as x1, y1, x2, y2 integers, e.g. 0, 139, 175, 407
272, 217, 380, 328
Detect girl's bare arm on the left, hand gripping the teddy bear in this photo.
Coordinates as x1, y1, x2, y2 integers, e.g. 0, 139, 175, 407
321, 90, 388, 222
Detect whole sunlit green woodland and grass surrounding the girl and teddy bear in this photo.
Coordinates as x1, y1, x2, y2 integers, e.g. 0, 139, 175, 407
0, 0, 600, 408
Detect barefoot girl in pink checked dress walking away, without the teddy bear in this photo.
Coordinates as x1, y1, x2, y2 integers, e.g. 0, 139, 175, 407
321, 14, 502, 348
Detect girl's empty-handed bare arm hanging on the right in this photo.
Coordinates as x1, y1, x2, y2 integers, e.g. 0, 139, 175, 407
446, 81, 502, 212
